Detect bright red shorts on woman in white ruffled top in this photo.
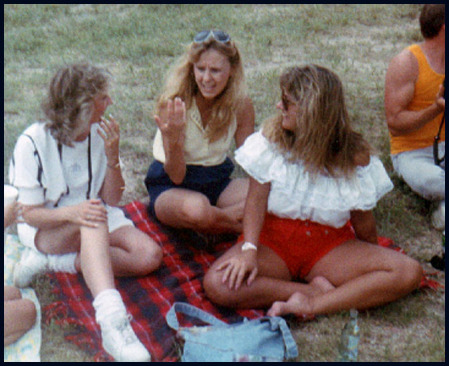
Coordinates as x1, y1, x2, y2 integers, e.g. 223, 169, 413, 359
239, 214, 355, 279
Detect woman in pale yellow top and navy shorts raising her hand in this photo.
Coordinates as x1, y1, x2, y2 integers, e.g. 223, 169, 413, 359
145, 30, 254, 237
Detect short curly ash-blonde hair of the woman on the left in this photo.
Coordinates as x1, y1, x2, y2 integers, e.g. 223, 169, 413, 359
42, 63, 110, 146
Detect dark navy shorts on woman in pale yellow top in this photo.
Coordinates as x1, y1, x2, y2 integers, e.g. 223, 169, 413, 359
145, 158, 234, 217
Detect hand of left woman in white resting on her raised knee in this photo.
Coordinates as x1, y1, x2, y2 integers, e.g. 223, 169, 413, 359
69, 199, 108, 228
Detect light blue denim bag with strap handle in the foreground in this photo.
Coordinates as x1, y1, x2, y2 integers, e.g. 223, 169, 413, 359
166, 302, 298, 362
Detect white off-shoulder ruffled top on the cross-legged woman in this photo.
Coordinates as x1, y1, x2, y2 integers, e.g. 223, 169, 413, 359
235, 131, 393, 228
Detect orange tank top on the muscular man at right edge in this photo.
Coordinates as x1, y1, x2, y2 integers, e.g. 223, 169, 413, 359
390, 44, 445, 154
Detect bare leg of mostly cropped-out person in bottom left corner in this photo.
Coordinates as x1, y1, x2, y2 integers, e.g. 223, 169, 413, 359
3, 286, 36, 346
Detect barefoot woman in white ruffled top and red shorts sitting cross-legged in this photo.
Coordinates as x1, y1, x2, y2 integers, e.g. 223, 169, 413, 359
204, 65, 422, 316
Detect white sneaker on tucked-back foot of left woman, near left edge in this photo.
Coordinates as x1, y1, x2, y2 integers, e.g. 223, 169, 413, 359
13, 248, 48, 288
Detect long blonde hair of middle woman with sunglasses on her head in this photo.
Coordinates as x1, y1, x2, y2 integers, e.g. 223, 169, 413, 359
156, 35, 245, 142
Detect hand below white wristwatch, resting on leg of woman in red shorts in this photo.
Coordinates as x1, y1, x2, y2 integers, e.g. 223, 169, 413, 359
217, 250, 257, 290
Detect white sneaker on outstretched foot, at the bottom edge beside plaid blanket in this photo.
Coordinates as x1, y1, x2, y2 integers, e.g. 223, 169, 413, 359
100, 313, 151, 362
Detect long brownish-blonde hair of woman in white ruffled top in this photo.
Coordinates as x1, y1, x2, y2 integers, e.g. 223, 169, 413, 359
263, 65, 370, 177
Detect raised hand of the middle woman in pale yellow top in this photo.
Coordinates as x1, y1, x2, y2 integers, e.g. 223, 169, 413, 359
154, 97, 186, 146
